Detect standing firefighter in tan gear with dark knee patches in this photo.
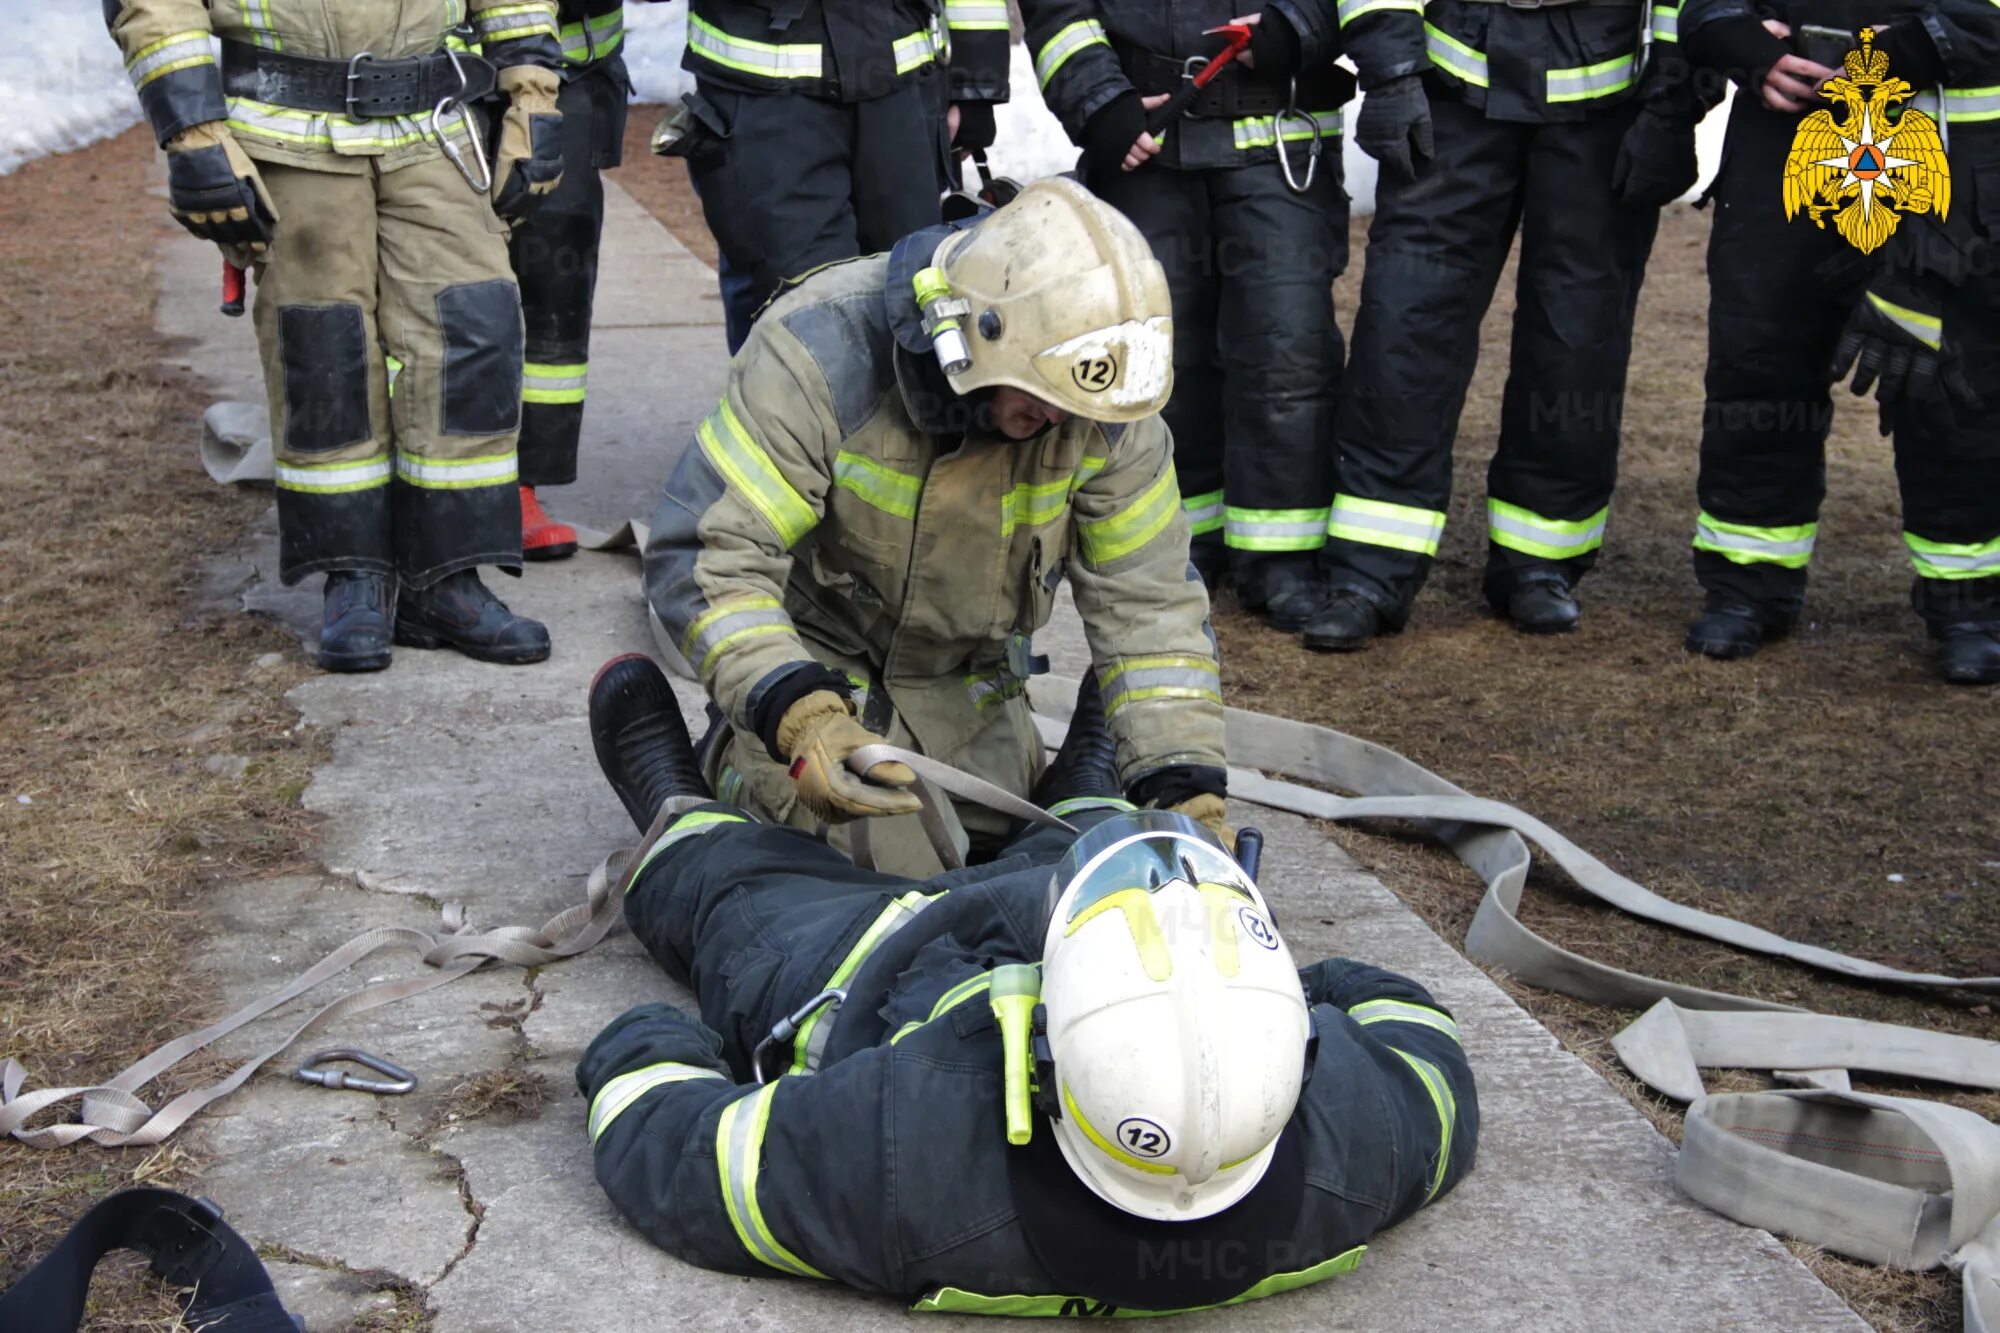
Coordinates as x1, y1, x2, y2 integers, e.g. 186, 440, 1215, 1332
106, 0, 562, 671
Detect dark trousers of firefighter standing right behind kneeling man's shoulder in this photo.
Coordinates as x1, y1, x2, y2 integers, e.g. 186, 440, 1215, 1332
688, 70, 950, 354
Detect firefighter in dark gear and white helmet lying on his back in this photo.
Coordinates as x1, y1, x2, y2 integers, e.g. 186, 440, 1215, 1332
576, 654, 1478, 1315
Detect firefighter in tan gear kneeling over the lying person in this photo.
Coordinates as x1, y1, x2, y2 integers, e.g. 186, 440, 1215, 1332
646, 178, 1224, 873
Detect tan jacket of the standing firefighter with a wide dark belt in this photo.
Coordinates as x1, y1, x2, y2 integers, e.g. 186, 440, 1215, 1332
106, 0, 562, 172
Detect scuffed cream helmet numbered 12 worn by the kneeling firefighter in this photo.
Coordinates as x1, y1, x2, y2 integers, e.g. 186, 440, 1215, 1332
920, 176, 1174, 420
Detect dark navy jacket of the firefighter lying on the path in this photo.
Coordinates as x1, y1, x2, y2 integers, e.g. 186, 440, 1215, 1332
576, 824, 1478, 1315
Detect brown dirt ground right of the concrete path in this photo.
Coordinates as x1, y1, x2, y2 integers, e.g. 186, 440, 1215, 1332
618, 108, 2000, 1331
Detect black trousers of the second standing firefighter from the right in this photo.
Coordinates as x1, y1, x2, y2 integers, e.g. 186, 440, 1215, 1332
1326, 94, 1660, 626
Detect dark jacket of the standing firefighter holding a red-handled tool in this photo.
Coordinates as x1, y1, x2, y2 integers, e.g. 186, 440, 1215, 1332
1022, 0, 1368, 170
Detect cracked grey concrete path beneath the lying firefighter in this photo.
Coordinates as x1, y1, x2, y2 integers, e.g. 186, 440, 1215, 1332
160, 179, 1866, 1333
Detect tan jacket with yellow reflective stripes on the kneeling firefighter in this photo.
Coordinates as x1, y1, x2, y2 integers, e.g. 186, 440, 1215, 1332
646, 242, 1222, 787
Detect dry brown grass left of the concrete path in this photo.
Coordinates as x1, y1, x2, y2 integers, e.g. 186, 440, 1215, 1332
0, 130, 318, 1329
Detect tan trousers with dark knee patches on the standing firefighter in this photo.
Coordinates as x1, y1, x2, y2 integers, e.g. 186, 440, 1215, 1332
256, 156, 522, 588
